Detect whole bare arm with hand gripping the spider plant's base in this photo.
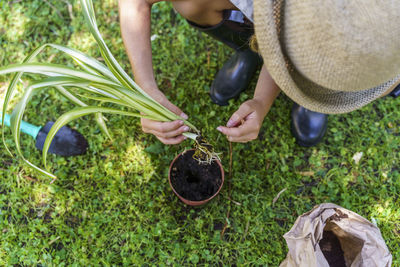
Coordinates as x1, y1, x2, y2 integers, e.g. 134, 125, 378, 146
119, 0, 189, 144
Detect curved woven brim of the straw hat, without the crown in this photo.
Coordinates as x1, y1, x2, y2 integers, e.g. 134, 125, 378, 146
254, 0, 400, 114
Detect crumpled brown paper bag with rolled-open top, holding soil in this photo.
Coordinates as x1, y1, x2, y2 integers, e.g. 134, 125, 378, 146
280, 203, 392, 267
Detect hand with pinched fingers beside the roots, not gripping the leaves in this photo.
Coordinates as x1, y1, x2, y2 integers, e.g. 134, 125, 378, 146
217, 99, 269, 143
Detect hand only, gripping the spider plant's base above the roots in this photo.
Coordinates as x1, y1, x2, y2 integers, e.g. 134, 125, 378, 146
141, 92, 189, 145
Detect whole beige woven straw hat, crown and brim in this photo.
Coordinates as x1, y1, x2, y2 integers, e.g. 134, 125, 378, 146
254, 0, 400, 113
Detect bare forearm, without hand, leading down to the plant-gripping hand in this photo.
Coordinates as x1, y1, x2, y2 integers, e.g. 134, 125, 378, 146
119, 0, 158, 92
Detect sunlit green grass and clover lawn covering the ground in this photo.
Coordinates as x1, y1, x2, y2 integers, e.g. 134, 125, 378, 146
0, 0, 400, 266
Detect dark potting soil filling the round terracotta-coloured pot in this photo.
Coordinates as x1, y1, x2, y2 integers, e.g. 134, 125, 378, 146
171, 150, 222, 201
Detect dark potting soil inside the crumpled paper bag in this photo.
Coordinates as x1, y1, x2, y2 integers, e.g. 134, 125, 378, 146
319, 231, 346, 267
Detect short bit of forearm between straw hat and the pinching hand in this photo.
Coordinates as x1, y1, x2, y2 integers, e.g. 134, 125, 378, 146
253, 65, 281, 113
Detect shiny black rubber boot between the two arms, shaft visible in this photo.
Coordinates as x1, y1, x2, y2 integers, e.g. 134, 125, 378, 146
188, 10, 262, 106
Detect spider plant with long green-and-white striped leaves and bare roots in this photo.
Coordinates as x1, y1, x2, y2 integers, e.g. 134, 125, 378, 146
0, 0, 218, 179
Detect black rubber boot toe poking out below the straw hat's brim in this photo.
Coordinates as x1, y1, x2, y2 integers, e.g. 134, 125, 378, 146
291, 103, 328, 147
